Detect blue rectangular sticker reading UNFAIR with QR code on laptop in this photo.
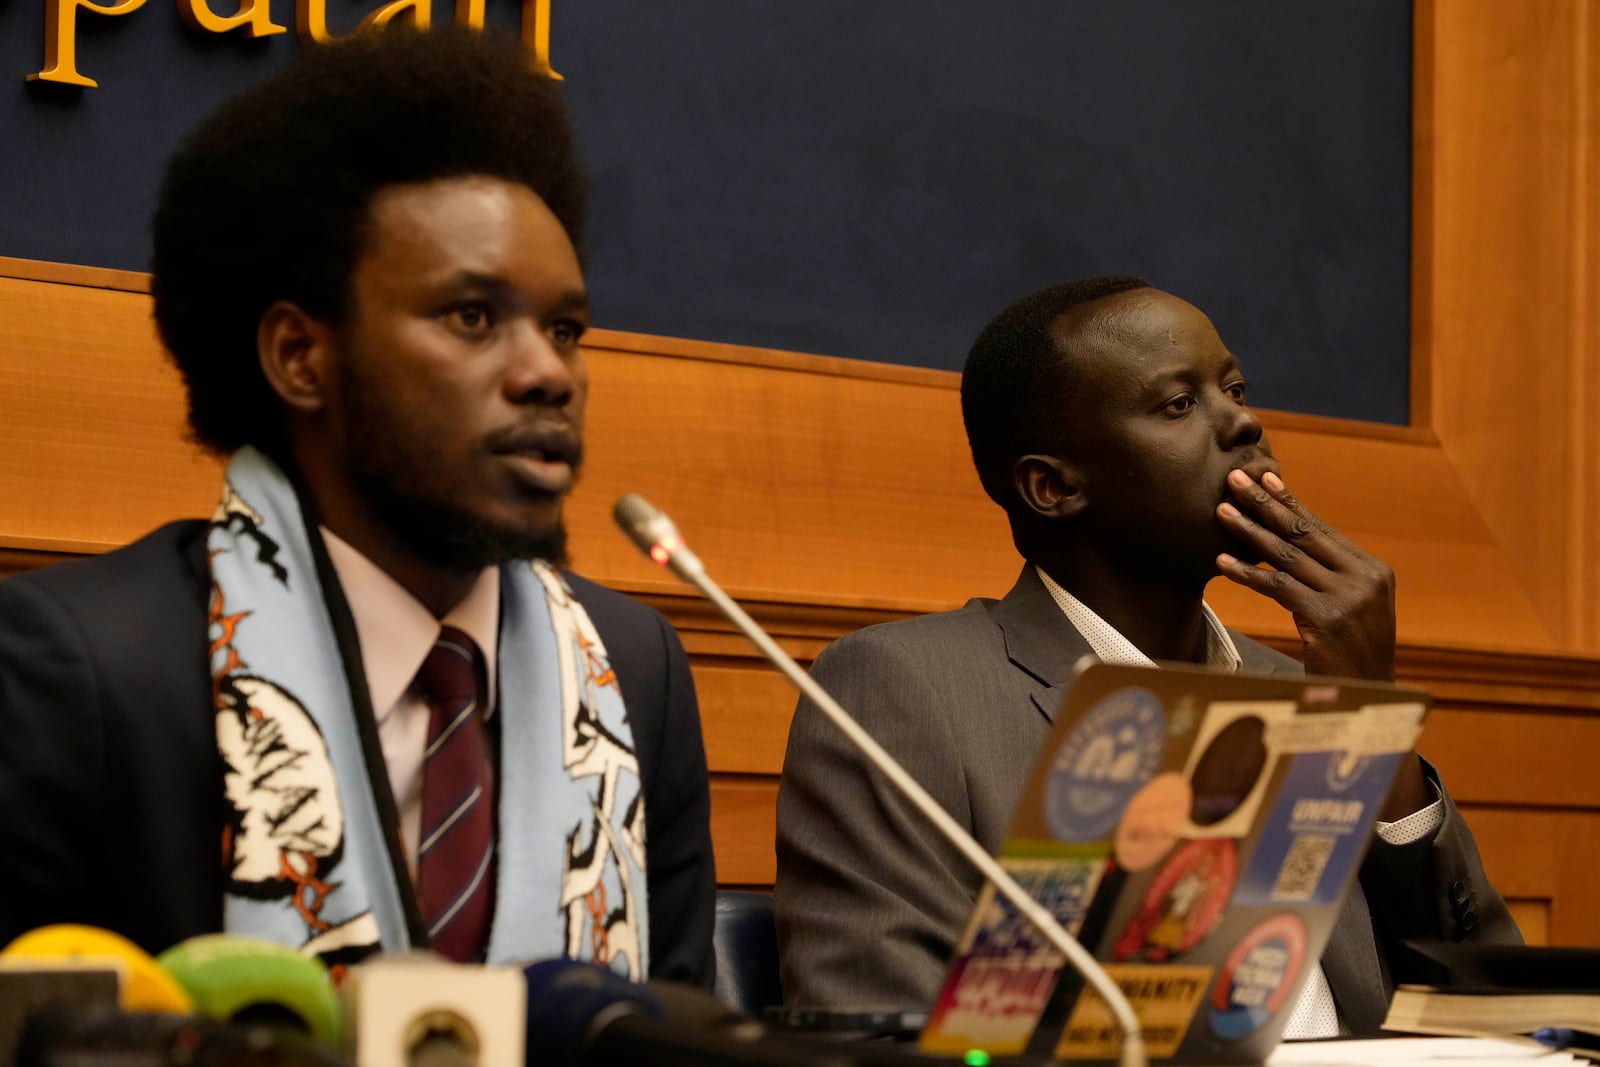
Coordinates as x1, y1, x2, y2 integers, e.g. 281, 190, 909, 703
1234, 752, 1410, 905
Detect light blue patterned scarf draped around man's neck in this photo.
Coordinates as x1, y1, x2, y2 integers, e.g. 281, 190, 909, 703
206, 448, 650, 979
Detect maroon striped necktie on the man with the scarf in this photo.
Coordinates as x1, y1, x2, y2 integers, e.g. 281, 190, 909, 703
416, 625, 494, 963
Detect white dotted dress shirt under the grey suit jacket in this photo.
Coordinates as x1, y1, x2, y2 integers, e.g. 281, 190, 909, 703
1034, 566, 1445, 1041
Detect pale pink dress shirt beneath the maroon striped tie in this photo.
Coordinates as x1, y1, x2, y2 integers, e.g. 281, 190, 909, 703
322, 528, 499, 878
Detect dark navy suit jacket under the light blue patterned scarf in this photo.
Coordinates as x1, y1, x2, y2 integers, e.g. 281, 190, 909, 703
0, 522, 715, 985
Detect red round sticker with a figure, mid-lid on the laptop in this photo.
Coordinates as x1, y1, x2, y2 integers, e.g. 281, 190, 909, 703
1115, 837, 1238, 963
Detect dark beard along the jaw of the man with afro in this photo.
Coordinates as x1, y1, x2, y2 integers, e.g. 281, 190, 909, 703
341, 352, 578, 574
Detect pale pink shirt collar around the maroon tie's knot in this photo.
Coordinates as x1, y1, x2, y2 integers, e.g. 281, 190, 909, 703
322, 526, 499, 723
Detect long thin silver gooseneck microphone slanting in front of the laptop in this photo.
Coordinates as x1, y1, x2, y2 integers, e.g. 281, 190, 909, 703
611, 493, 1146, 1067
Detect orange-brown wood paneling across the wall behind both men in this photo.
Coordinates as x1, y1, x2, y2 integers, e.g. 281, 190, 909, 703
0, 0, 1600, 944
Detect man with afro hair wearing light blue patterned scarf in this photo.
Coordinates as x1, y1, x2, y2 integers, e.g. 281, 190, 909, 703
0, 27, 715, 984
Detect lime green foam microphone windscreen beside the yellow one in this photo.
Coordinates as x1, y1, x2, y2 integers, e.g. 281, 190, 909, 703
155, 934, 344, 1048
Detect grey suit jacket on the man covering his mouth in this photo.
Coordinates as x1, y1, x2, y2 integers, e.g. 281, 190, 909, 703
774, 566, 1517, 1033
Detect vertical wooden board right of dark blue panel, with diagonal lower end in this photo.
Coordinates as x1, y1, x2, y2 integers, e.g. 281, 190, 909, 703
1414, 0, 1600, 648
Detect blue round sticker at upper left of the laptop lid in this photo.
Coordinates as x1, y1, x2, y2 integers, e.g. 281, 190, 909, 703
1045, 686, 1166, 843
